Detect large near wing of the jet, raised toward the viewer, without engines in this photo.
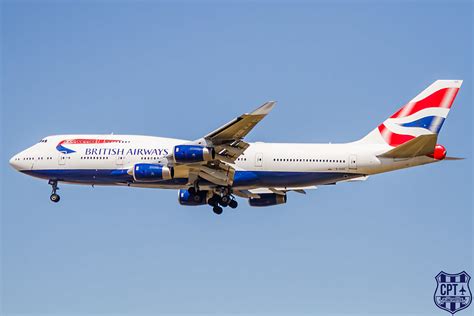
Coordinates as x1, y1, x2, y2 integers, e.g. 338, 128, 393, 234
168, 101, 276, 186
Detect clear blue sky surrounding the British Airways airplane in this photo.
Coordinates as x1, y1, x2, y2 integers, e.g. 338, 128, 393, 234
0, 1, 474, 315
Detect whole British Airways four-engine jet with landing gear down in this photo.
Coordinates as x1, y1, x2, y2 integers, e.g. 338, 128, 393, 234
10, 80, 462, 214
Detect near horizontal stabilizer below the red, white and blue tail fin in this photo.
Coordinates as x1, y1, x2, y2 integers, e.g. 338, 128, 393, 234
378, 134, 438, 158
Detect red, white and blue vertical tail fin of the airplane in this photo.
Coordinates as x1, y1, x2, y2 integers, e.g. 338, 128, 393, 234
358, 80, 462, 147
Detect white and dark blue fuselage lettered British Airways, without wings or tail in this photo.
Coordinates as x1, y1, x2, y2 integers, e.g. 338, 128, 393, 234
10, 135, 437, 189
